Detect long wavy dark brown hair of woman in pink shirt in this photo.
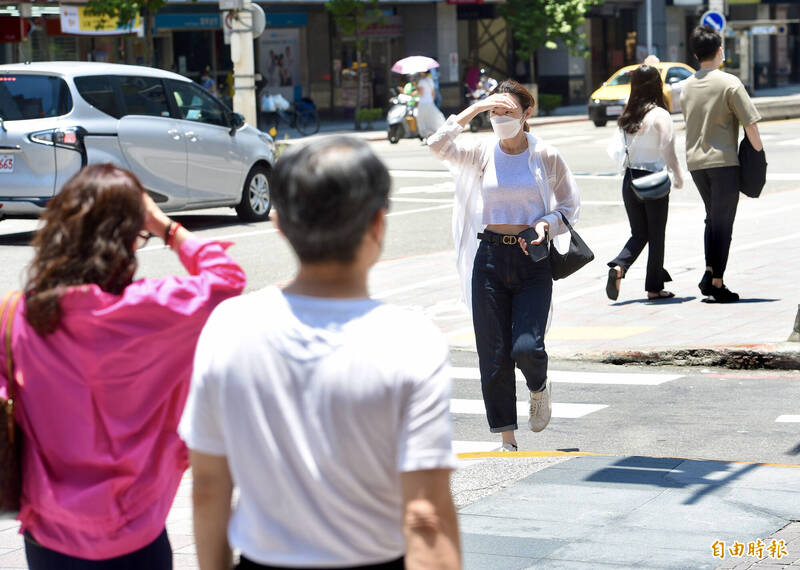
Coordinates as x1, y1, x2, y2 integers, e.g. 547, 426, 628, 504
25, 164, 145, 336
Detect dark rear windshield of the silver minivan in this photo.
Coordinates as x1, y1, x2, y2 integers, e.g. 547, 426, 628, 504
0, 74, 72, 121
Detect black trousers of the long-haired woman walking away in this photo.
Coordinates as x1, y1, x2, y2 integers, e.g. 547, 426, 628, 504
608, 169, 672, 293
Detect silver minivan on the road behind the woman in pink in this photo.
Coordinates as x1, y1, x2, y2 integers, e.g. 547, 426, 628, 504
0, 62, 275, 221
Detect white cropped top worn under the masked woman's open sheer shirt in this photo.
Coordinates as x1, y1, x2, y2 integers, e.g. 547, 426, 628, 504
481, 142, 546, 226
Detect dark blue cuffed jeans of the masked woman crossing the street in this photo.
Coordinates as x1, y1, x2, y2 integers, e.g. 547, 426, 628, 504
472, 232, 553, 433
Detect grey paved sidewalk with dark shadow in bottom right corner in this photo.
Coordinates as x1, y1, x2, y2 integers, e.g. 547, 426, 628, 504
460, 453, 800, 570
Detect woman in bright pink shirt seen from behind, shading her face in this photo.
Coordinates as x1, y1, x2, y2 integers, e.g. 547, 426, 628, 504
0, 164, 245, 570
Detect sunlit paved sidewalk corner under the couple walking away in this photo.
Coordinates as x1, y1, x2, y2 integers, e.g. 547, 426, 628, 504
370, 183, 800, 368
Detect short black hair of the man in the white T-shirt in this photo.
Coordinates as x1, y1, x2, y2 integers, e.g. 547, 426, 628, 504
271, 136, 391, 263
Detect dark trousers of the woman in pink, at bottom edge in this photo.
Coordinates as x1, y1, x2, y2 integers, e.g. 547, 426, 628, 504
25, 529, 172, 570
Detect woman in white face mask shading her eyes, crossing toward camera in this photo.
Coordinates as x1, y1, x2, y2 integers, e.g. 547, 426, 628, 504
428, 80, 580, 451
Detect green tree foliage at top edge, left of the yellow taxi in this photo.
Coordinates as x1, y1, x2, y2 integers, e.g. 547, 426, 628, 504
501, 0, 602, 82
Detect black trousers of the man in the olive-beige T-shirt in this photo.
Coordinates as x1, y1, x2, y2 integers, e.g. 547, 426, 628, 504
691, 166, 739, 279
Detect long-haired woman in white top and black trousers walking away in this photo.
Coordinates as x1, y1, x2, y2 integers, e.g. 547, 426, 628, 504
606, 65, 683, 301
